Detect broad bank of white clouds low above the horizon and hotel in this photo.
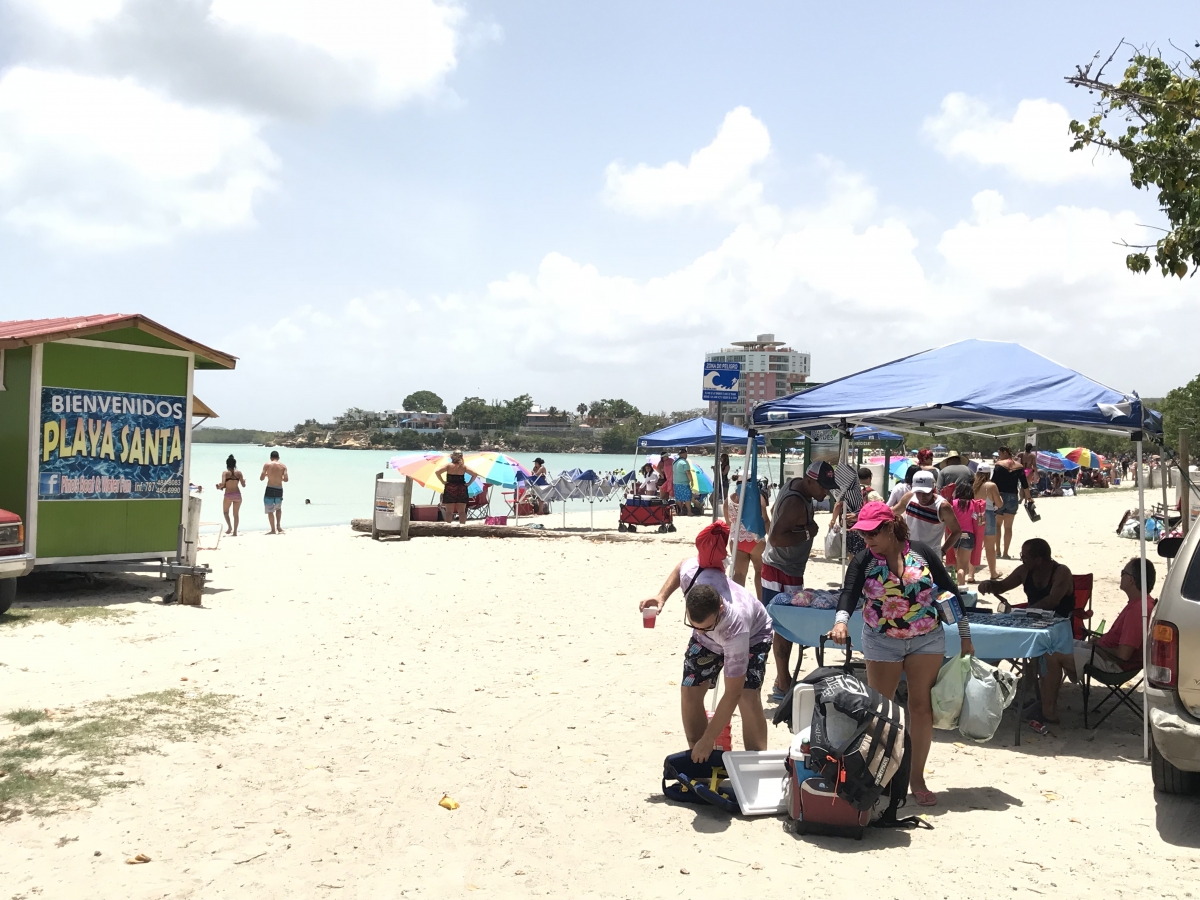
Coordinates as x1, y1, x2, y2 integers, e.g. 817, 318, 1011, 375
230, 103, 1200, 421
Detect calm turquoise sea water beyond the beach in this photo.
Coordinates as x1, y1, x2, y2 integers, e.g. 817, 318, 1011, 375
191, 444, 738, 532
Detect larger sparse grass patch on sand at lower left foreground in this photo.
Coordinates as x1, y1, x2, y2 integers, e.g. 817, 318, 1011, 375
0, 690, 236, 820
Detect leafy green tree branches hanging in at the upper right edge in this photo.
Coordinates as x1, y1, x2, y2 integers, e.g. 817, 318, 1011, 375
1067, 41, 1200, 278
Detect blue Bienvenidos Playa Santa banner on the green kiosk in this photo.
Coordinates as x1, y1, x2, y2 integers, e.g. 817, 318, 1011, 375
37, 388, 187, 500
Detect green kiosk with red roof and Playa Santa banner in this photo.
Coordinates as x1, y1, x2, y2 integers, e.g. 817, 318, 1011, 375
0, 314, 236, 610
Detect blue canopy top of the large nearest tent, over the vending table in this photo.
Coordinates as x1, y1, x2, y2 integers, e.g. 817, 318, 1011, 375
752, 340, 1162, 436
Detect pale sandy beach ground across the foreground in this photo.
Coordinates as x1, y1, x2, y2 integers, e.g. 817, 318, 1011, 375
0, 490, 1200, 900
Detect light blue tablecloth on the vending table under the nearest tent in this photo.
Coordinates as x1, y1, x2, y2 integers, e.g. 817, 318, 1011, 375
767, 605, 1075, 659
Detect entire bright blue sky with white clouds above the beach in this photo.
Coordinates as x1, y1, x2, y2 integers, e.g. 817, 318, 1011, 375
0, 0, 1200, 428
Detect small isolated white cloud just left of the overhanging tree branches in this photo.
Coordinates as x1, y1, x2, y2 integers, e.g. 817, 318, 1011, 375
924, 94, 1127, 185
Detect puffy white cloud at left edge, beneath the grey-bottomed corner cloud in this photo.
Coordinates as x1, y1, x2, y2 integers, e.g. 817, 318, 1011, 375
0, 67, 275, 248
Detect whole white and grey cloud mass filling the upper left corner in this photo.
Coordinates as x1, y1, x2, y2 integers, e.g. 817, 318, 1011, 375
0, 0, 466, 250
